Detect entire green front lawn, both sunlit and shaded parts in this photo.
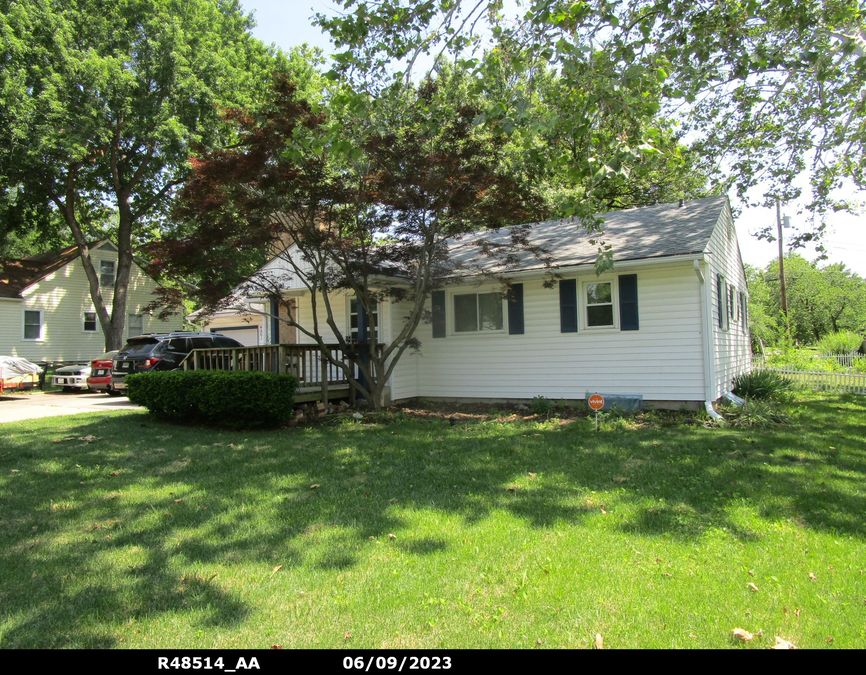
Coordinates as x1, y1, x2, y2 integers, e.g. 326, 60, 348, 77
0, 395, 866, 649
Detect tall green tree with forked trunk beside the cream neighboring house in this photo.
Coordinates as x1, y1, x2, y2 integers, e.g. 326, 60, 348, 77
0, 0, 275, 349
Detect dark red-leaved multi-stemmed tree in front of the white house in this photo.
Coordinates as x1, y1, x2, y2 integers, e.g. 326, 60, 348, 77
152, 78, 544, 407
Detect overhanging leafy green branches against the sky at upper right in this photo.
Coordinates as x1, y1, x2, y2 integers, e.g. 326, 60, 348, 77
318, 0, 866, 241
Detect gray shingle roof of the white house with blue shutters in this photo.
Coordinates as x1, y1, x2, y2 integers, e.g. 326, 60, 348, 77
442, 196, 728, 272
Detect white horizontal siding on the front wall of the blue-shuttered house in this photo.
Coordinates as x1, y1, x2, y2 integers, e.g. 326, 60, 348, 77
408, 263, 704, 401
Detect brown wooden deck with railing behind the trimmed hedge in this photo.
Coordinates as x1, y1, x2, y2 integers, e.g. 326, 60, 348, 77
181, 344, 383, 405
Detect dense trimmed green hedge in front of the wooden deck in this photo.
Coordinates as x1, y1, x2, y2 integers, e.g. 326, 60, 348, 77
126, 370, 298, 429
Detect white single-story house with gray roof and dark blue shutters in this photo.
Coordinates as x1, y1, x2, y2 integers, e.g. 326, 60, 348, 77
230, 197, 751, 406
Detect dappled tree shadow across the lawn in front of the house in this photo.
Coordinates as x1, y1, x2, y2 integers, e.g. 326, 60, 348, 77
0, 397, 866, 648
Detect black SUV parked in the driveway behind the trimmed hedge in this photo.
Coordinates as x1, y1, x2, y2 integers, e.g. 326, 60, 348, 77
111, 331, 243, 391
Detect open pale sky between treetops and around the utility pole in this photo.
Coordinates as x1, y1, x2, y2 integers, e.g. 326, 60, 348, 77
241, 0, 866, 277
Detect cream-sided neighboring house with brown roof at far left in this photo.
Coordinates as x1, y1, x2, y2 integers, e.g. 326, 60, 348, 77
0, 240, 181, 362
